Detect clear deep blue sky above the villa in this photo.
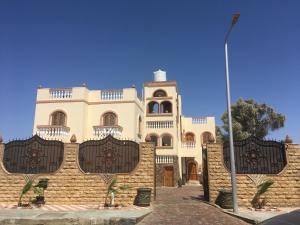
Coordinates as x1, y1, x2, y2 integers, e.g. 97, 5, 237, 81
0, 0, 300, 143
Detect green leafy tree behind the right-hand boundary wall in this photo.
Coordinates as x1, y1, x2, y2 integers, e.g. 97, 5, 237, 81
218, 99, 285, 141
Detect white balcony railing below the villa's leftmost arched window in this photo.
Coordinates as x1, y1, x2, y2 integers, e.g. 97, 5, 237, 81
37, 125, 70, 137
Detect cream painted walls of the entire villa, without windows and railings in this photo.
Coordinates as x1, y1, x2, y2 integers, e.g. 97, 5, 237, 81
33, 74, 215, 178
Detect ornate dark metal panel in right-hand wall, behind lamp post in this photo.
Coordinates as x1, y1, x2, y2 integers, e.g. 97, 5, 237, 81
223, 136, 287, 174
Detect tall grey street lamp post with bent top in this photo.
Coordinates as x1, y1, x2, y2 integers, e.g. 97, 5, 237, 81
225, 13, 240, 213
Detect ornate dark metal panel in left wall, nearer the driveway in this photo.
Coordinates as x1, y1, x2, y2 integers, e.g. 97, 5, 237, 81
79, 135, 139, 174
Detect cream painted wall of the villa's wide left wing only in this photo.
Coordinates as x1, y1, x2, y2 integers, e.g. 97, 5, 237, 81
33, 87, 143, 142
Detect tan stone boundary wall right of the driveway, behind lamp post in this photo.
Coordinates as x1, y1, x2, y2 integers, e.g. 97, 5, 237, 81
207, 144, 300, 207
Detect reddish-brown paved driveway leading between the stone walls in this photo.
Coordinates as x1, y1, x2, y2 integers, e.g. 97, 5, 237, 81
138, 186, 249, 225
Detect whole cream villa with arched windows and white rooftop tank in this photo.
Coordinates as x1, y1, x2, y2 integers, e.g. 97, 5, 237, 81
33, 70, 215, 186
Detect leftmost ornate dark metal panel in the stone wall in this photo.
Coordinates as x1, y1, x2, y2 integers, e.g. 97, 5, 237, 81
3, 135, 64, 174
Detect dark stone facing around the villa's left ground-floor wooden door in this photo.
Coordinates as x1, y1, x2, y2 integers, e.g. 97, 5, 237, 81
155, 156, 179, 187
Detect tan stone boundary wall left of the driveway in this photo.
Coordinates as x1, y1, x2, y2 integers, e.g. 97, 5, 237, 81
0, 143, 154, 205
